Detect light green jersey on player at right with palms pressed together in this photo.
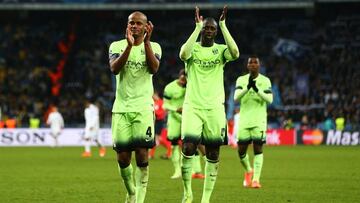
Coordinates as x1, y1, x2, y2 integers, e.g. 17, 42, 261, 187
236, 74, 271, 130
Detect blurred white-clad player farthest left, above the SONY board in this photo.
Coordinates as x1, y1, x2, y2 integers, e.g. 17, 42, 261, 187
46, 106, 64, 147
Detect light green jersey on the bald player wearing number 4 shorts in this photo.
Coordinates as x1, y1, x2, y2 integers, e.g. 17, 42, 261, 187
109, 39, 161, 113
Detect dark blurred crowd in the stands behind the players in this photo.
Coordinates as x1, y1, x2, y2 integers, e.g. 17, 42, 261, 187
0, 3, 360, 130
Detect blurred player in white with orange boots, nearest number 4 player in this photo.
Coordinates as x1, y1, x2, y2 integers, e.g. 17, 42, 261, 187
81, 100, 106, 157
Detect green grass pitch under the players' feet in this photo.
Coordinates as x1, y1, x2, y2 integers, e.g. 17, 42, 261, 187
0, 146, 360, 203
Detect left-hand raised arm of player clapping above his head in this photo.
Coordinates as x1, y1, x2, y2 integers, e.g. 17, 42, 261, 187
179, 6, 203, 61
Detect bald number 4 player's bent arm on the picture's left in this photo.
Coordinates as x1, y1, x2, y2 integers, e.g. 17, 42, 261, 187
109, 26, 134, 75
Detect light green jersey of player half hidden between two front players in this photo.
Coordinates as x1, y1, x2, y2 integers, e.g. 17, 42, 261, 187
164, 80, 186, 120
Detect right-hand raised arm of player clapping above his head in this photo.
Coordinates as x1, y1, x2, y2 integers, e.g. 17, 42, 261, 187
219, 5, 240, 61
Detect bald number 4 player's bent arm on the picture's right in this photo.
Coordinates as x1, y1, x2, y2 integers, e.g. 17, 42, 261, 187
144, 21, 160, 74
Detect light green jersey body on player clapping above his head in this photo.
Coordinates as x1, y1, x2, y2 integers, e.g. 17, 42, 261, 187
184, 42, 228, 109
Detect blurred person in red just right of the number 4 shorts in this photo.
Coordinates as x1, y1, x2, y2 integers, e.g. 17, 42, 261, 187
149, 91, 171, 159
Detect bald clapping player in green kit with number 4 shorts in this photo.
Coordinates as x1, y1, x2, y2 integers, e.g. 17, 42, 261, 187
109, 11, 161, 203
